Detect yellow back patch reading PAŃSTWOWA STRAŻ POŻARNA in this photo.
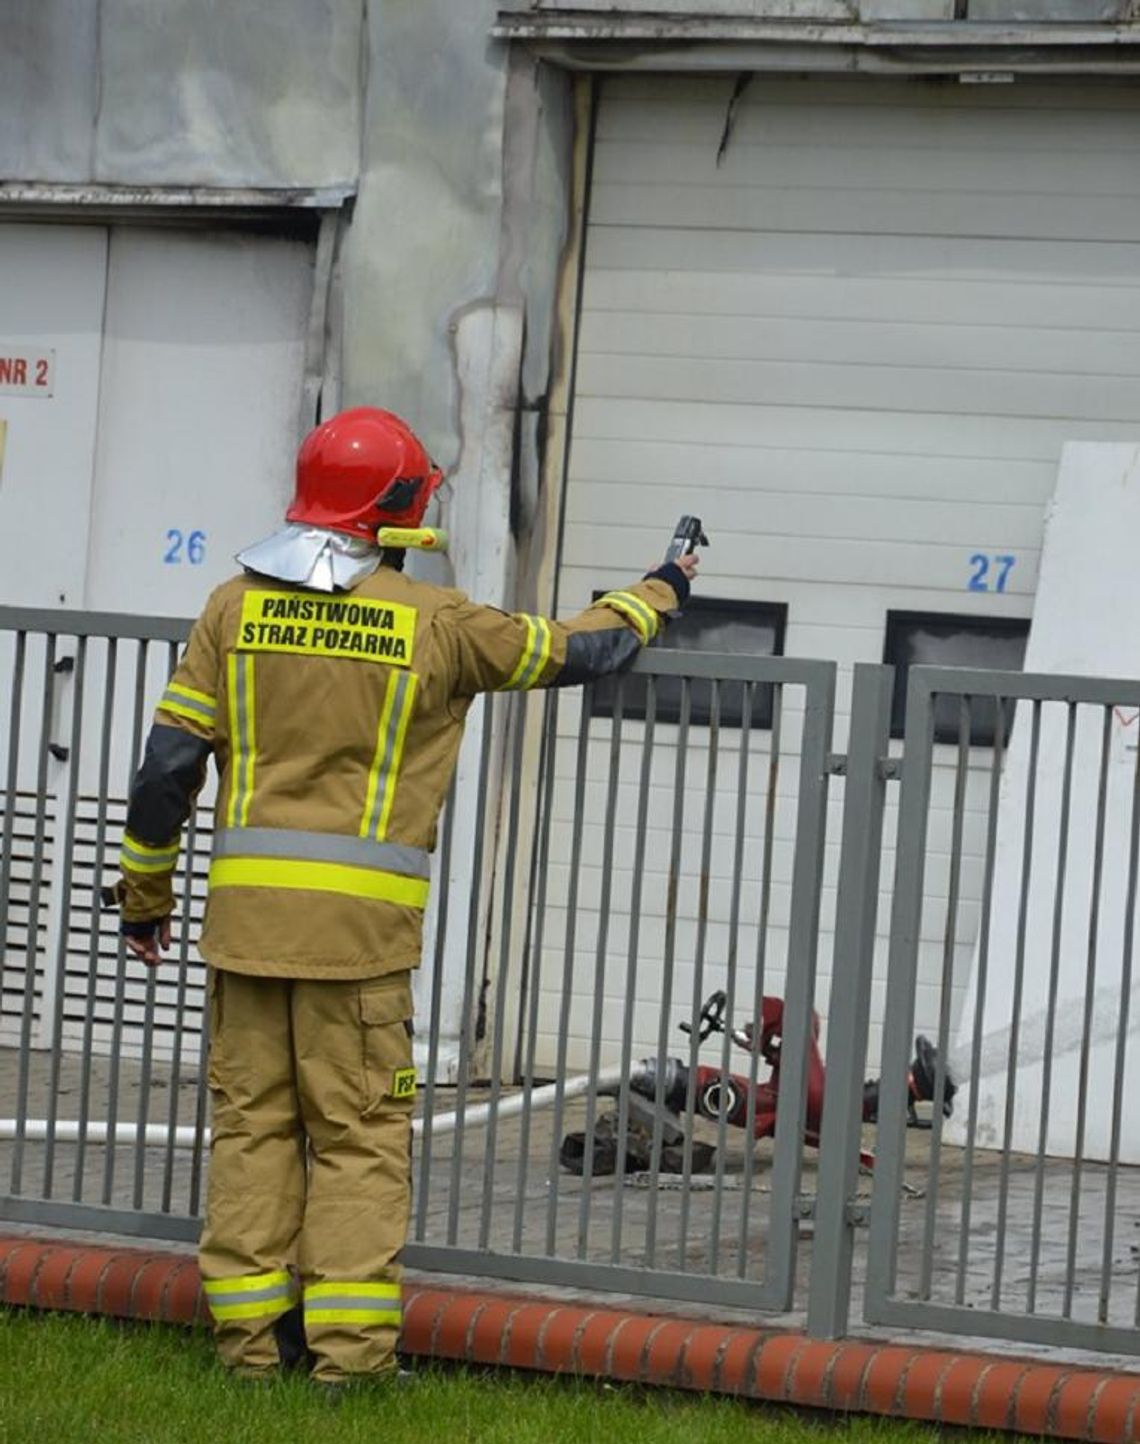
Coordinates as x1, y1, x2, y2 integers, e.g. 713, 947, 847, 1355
237, 588, 418, 667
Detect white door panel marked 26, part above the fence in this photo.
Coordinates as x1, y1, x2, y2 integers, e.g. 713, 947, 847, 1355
87, 227, 312, 617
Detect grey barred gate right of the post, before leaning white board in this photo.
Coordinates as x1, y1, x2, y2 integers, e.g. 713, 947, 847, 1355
865, 667, 1140, 1353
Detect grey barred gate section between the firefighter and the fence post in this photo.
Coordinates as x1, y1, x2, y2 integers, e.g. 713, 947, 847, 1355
405, 648, 835, 1310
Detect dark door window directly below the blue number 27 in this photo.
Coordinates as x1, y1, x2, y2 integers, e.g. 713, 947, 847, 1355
883, 612, 1029, 747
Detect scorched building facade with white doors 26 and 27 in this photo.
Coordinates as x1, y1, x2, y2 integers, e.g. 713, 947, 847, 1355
0, 0, 1140, 1085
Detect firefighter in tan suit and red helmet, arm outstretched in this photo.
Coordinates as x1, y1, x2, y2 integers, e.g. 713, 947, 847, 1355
114, 407, 696, 1386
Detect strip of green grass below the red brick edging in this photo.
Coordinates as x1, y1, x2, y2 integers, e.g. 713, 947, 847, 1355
0, 1308, 976, 1444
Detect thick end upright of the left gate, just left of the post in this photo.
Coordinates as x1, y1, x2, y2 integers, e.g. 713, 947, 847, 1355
767, 667, 835, 1308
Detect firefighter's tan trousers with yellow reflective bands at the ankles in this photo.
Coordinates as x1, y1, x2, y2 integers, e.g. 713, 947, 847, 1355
199, 969, 415, 1382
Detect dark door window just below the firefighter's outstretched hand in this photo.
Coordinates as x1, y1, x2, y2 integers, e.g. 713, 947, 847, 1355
591, 592, 787, 729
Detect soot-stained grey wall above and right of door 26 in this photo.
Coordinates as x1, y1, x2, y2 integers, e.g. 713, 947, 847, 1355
0, 0, 572, 599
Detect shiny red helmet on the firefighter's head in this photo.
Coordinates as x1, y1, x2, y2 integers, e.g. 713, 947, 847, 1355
285, 406, 444, 539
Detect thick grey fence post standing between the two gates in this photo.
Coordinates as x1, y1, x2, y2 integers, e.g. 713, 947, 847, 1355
808, 663, 894, 1339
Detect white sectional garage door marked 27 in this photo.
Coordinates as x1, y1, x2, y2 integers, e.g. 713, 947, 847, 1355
543, 77, 1140, 1074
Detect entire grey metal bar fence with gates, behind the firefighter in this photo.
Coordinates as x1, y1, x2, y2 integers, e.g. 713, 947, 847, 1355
0, 611, 1140, 1353
